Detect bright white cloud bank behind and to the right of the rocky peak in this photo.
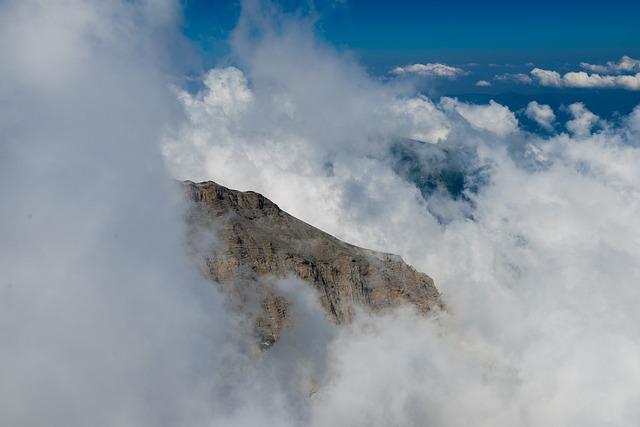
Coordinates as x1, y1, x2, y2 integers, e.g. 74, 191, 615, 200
165, 1, 640, 426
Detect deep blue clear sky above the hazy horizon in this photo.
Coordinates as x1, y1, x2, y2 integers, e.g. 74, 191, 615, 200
185, 0, 640, 62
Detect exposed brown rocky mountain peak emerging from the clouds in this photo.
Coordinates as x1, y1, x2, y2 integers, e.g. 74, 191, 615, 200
184, 181, 440, 346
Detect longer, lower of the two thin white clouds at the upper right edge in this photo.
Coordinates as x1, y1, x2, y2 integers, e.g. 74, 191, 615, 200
531, 68, 640, 90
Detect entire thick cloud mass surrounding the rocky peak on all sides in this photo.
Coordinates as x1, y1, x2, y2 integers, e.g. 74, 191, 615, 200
0, 0, 640, 427
